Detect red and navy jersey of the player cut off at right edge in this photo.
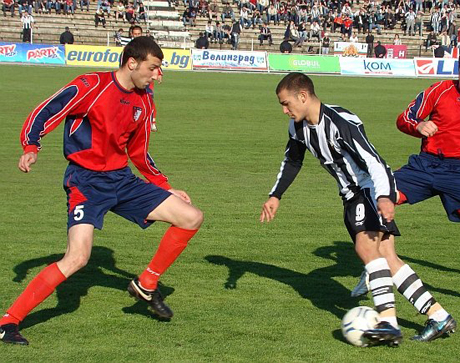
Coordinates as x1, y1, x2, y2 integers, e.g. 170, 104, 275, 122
396, 80, 460, 159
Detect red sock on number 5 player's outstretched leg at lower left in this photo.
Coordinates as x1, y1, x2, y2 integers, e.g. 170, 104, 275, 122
0, 263, 67, 325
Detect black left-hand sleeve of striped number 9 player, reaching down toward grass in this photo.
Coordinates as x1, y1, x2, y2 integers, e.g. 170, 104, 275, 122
269, 123, 307, 199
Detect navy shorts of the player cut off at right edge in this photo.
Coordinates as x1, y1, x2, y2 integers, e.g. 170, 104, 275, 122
394, 152, 460, 222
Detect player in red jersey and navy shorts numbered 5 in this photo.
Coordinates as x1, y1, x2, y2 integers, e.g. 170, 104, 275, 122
0, 37, 203, 345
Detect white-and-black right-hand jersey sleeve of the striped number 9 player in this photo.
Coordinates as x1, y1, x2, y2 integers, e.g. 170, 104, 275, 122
341, 124, 396, 203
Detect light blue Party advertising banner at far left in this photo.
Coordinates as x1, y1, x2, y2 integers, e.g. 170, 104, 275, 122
0, 42, 65, 64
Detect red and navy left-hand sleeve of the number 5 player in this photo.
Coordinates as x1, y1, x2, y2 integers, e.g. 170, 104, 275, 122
20, 74, 100, 153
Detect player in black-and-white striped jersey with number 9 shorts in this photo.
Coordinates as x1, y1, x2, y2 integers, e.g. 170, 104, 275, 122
260, 73, 454, 346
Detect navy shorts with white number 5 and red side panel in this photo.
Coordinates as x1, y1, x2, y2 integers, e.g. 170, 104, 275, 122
64, 164, 171, 229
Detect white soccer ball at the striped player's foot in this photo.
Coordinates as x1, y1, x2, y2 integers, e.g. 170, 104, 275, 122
342, 306, 379, 347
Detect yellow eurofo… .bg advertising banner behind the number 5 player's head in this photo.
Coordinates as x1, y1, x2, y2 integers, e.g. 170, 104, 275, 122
65, 44, 192, 70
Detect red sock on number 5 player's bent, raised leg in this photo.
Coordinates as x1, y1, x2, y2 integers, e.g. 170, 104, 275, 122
139, 226, 198, 290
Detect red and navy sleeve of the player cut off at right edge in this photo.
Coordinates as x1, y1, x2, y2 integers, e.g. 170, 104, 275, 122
396, 82, 441, 138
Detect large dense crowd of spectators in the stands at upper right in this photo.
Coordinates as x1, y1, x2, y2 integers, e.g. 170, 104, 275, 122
181, 0, 460, 52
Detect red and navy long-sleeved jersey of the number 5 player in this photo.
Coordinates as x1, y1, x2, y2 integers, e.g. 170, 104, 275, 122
21, 72, 171, 189
